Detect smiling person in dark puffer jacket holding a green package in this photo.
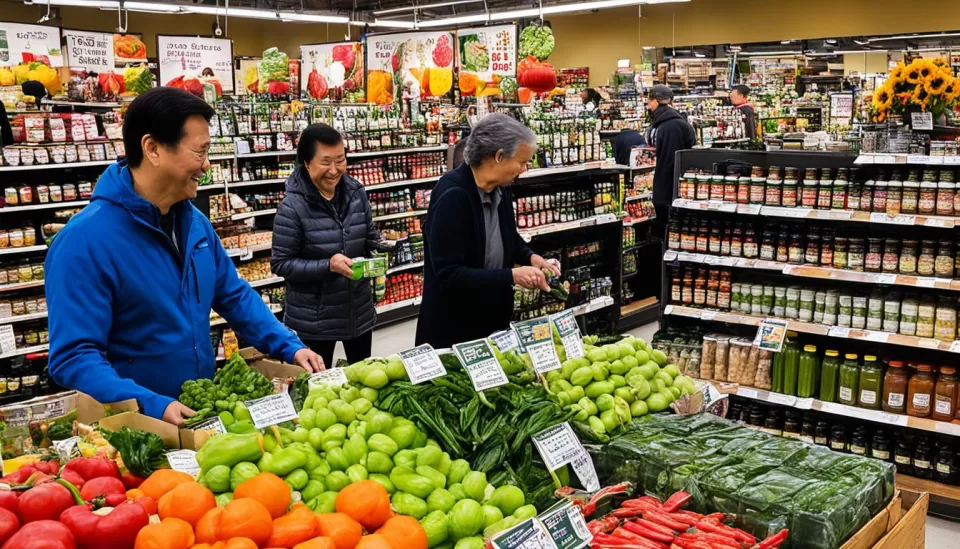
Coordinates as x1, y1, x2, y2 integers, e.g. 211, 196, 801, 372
270, 124, 380, 365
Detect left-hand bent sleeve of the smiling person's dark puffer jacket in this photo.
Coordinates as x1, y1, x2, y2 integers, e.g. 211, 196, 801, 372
270, 195, 330, 283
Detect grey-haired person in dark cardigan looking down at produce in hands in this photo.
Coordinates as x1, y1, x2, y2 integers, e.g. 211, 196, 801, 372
417, 113, 560, 348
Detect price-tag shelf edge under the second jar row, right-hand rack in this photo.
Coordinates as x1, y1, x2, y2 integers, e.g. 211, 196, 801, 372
663, 250, 960, 291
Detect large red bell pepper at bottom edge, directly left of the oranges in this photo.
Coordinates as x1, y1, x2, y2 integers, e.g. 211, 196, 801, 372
60, 501, 150, 549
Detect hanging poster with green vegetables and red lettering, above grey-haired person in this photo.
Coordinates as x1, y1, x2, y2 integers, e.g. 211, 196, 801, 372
457, 25, 517, 96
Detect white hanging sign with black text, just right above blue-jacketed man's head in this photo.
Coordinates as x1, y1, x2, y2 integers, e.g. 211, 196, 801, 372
157, 35, 234, 93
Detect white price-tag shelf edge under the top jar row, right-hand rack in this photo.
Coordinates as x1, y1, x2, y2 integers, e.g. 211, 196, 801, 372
673, 198, 957, 229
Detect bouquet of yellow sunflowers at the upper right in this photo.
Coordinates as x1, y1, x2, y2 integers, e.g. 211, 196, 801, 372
873, 58, 960, 122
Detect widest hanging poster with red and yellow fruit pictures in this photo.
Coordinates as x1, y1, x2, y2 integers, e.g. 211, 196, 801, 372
367, 32, 454, 105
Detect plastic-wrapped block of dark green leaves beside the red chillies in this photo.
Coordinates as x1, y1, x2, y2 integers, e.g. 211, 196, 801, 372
594, 414, 895, 549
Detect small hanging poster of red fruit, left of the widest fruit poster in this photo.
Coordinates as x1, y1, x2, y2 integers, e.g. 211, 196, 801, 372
300, 42, 363, 101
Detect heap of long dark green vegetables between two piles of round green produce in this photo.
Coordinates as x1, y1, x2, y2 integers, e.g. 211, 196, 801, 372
377, 355, 573, 508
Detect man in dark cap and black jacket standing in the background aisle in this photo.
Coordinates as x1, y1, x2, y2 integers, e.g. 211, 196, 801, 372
647, 85, 696, 234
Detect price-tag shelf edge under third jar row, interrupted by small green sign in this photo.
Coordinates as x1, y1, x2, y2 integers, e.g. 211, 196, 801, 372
663, 305, 948, 353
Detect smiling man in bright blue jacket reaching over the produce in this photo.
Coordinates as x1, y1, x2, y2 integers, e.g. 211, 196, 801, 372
46, 87, 323, 425
